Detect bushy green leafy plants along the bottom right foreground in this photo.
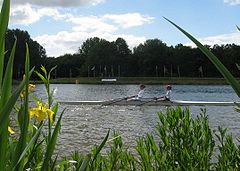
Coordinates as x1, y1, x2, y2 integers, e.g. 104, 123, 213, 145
55, 107, 240, 171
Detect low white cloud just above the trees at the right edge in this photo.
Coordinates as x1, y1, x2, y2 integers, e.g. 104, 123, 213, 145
185, 33, 240, 47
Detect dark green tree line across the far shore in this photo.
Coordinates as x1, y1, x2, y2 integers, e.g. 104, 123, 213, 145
6, 29, 240, 78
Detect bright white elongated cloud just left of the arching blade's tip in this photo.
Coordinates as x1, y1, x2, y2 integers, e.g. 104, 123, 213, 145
103, 13, 154, 28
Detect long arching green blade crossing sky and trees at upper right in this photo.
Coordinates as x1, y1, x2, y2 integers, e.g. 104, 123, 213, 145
164, 17, 240, 97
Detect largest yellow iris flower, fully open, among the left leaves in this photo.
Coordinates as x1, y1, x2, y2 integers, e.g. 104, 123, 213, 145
29, 102, 54, 123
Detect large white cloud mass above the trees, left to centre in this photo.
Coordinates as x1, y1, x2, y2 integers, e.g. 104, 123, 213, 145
7, 3, 153, 57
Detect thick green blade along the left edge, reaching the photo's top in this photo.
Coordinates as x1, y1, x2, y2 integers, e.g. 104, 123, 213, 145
0, 0, 10, 91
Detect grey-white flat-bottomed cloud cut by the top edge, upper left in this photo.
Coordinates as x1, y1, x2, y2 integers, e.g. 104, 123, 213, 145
9, 0, 105, 8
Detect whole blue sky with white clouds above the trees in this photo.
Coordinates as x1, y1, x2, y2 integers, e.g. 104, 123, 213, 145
4, 0, 240, 57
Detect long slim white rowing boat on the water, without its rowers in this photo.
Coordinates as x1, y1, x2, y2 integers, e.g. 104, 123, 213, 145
59, 98, 240, 106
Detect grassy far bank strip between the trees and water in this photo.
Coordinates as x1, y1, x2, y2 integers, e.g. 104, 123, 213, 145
27, 77, 239, 85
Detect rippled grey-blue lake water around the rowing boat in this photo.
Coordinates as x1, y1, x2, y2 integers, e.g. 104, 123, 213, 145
32, 84, 240, 155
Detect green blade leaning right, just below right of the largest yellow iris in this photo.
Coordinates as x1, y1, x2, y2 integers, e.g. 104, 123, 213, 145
41, 110, 65, 171
